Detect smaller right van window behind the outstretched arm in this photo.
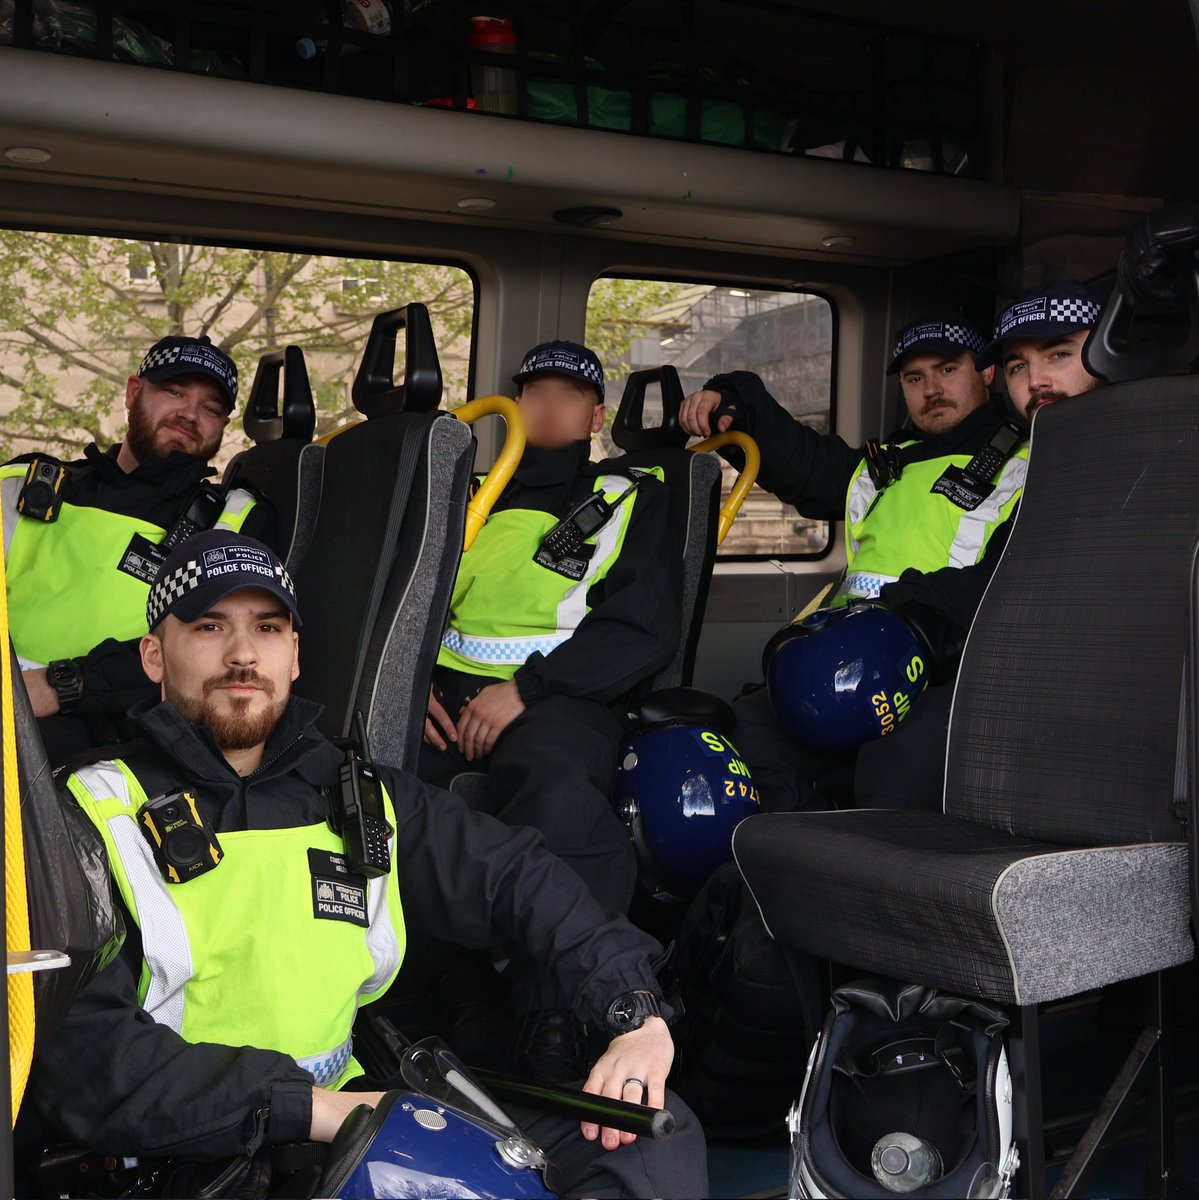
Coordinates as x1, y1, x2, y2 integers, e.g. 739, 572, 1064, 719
587, 278, 833, 559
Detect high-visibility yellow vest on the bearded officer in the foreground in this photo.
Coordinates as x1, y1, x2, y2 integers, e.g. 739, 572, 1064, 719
67, 760, 404, 1088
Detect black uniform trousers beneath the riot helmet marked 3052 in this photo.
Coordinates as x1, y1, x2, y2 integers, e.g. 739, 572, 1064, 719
733, 683, 953, 812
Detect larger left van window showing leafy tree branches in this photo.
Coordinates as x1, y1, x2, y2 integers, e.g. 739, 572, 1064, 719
0, 229, 475, 467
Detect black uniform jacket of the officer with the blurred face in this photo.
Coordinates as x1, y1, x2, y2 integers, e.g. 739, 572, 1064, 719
477, 442, 683, 704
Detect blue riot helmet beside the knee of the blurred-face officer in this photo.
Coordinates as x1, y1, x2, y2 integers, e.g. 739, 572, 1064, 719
616, 688, 759, 896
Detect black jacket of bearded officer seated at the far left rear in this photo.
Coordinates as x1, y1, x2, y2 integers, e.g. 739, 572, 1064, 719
12, 443, 278, 714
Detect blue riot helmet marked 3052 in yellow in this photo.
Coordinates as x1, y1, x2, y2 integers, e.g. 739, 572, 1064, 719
763, 600, 933, 752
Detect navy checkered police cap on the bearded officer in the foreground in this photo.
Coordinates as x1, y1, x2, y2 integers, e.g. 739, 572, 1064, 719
145, 529, 300, 629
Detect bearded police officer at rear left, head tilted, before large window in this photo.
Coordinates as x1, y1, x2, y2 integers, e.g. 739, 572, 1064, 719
0, 337, 276, 763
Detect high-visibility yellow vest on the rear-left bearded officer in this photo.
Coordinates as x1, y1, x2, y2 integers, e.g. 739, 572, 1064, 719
0, 463, 254, 668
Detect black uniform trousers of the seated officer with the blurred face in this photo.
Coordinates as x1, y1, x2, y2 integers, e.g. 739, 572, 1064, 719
416, 667, 636, 912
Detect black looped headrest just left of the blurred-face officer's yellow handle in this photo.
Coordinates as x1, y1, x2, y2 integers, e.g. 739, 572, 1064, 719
352, 304, 442, 418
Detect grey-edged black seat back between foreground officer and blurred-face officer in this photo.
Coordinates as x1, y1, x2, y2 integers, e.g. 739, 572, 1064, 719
295, 412, 473, 766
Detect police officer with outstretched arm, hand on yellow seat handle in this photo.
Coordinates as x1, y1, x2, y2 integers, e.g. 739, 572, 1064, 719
681, 312, 1025, 810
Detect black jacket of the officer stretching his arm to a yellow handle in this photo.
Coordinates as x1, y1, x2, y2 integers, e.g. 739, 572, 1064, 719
705, 371, 1027, 630
